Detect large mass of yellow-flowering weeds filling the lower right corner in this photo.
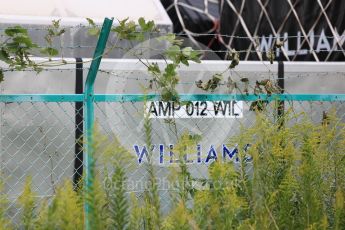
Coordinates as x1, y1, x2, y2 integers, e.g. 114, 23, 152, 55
164, 112, 345, 229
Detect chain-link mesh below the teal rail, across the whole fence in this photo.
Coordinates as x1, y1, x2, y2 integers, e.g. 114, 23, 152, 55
0, 97, 345, 222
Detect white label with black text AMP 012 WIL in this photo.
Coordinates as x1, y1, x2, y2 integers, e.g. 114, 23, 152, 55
146, 101, 243, 119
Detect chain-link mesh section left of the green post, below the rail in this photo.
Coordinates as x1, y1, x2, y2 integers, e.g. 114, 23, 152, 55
0, 102, 79, 222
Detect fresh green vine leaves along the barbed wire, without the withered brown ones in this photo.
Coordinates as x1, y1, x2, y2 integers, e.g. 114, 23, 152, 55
0, 14, 202, 104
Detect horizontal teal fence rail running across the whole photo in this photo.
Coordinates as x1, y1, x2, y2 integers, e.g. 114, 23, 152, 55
0, 94, 345, 102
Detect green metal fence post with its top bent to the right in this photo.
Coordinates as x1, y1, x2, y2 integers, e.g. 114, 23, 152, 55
84, 18, 113, 230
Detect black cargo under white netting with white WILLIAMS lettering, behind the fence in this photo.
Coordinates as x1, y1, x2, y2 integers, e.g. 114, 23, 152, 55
161, 0, 345, 61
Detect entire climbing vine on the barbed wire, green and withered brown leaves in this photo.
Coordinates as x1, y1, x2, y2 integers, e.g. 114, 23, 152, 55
0, 15, 284, 110
